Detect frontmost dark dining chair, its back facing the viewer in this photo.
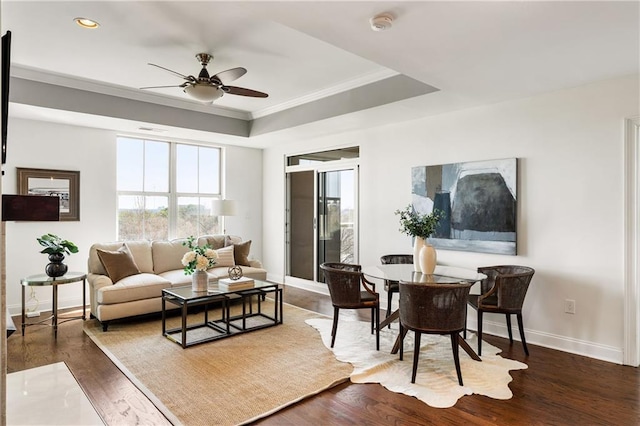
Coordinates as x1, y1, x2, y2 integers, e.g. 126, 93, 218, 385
399, 281, 473, 386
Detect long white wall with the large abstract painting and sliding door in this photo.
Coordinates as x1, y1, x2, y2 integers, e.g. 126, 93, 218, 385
263, 76, 639, 362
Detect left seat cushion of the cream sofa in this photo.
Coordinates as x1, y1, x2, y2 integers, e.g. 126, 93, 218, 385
97, 273, 171, 305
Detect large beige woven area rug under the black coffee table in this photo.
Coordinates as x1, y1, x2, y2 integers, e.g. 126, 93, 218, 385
84, 299, 353, 425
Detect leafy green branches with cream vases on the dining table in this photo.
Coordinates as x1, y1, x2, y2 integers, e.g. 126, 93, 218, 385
395, 204, 442, 274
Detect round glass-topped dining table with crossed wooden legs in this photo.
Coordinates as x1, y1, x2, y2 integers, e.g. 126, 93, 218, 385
362, 264, 487, 361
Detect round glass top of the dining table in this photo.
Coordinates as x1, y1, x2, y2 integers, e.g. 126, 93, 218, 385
362, 264, 487, 284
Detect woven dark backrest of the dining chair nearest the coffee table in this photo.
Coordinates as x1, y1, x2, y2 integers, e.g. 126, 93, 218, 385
320, 263, 362, 308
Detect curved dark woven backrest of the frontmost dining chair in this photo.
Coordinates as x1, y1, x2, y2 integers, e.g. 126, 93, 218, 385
400, 281, 473, 334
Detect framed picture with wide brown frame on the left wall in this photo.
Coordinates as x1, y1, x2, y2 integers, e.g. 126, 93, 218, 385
17, 167, 80, 221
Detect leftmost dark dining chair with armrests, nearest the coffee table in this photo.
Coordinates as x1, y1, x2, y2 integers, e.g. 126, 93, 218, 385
320, 263, 380, 350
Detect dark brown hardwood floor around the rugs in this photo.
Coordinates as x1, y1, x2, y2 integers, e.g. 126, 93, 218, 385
7, 287, 640, 425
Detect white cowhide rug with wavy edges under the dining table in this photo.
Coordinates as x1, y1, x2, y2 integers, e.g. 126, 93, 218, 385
306, 318, 527, 408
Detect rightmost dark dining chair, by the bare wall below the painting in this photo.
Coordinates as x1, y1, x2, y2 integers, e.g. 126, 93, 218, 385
468, 265, 535, 355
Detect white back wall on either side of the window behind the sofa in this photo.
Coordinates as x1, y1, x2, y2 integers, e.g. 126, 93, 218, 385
2, 118, 262, 315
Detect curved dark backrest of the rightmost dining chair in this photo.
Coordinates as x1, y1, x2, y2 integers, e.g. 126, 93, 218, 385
478, 265, 535, 310
